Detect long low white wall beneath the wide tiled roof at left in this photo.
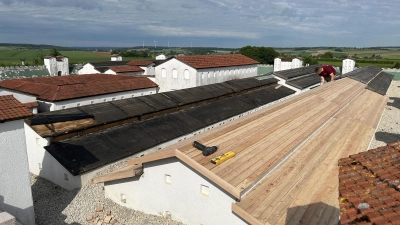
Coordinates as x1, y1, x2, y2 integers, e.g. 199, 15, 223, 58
38, 87, 157, 112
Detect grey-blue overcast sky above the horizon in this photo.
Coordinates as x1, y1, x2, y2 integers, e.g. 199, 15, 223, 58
0, 0, 400, 48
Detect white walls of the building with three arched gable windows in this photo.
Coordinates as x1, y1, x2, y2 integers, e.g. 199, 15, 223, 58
155, 59, 257, 92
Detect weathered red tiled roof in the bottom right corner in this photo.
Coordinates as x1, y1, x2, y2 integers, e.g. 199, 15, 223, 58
338, 140, 400, 224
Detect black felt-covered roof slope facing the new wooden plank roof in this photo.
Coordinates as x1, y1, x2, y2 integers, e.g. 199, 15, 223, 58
45, 82, 294, 175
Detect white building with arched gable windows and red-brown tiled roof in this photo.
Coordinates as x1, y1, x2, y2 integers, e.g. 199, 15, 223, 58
155, 54, 258, 92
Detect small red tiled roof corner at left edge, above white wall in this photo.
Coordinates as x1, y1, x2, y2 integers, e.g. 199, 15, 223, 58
0, 95, 33, 123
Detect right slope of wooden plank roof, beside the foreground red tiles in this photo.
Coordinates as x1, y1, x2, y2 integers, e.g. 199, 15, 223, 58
237, 90, 387, 224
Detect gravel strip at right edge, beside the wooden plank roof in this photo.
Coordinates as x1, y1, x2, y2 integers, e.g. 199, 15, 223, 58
370, 80, 400, 149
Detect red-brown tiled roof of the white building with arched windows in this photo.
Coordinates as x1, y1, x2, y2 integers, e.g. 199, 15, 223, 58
175, 54, 259, 69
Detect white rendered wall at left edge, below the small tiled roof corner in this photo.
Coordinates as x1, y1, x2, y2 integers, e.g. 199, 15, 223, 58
0, 120, 35, 225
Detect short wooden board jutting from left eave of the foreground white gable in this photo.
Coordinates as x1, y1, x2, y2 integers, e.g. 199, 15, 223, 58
90, 165, 143, 184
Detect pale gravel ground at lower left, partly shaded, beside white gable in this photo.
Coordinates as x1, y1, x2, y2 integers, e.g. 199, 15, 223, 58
30, 156, 183, 225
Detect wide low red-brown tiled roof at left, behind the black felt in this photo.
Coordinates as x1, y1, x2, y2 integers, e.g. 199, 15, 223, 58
0, 74, 158, 102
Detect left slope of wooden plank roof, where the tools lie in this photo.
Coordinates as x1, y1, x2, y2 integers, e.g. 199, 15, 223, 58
177, 78, 365, 191
